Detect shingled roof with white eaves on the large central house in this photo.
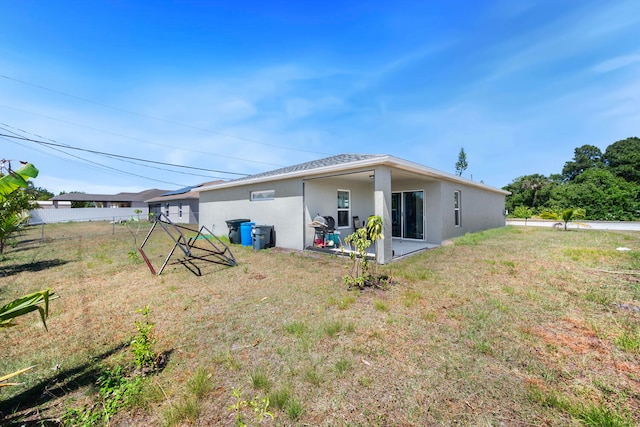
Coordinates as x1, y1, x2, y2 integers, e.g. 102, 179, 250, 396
194, 154, 509, 194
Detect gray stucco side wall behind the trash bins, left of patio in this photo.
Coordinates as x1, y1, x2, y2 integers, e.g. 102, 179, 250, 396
199, 179, 304, 249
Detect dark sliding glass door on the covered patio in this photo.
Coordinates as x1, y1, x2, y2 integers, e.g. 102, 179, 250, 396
391, 191, 424, 240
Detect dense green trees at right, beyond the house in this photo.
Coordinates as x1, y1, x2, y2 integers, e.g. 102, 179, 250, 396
503, 137, 640, 221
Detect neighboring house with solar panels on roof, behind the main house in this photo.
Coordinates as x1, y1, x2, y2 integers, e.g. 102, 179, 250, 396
145, 181, 224, 224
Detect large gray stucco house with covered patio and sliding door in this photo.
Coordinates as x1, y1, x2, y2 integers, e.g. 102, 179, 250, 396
196, 154, 509, 263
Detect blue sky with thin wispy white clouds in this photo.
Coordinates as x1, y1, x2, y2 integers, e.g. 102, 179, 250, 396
0, 0, 640, 194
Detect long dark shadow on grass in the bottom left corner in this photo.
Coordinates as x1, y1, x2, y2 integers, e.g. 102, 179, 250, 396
0, 343, 128, 426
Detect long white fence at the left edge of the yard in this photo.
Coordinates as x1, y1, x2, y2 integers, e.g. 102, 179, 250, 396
29, 208, 147, 225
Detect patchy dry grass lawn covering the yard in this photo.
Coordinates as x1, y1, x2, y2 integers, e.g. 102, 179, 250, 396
0, 223, 640, 426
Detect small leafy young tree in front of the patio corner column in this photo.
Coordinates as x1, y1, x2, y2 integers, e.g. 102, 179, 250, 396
343, 215, 391, 289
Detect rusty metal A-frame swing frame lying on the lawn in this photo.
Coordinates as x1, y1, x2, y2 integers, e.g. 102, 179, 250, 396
138, 212, 237, 276
